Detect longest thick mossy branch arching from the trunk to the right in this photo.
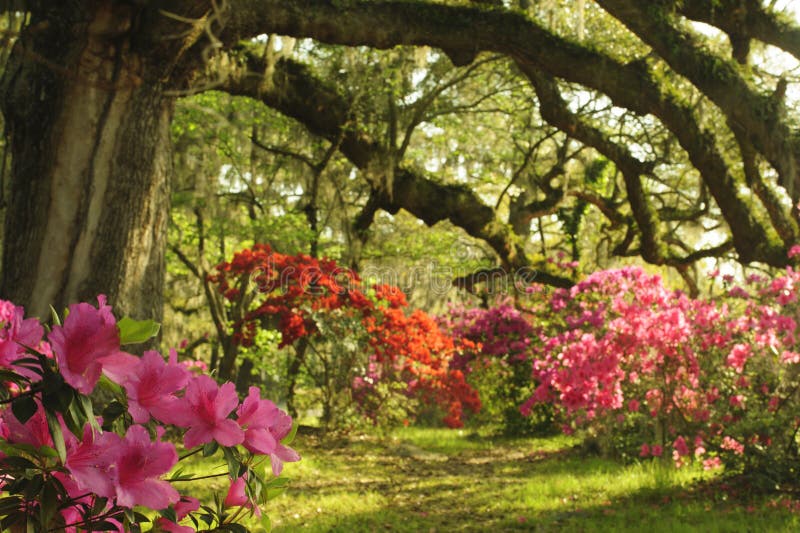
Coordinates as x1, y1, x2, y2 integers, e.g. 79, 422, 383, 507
214, 0, 788, 265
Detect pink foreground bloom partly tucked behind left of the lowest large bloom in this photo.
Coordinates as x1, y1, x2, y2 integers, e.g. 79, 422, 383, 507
65, 424, 122, 498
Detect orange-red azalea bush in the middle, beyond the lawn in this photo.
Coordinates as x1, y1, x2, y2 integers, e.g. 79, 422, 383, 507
209, 244, 480, 427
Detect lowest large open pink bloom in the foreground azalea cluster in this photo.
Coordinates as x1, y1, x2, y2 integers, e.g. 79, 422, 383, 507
114, 425, 180, 509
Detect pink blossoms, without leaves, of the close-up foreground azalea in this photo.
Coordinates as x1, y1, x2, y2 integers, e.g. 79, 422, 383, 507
0, 297, 300, 531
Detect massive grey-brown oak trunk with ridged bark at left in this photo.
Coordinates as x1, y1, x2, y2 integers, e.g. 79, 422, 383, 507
0, 2, 174, 320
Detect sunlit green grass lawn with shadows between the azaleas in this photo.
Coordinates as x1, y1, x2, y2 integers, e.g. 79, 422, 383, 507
178, 428, 800, 533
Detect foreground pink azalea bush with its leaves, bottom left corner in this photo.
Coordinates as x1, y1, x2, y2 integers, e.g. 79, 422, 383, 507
0, 297, 300, 532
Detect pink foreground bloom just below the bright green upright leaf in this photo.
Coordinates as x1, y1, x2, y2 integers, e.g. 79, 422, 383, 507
122, 350, 191, 424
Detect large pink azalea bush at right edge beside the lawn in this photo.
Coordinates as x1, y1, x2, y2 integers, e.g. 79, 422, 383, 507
521, 268, 800, 485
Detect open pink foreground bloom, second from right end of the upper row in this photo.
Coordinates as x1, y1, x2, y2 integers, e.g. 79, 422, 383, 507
173, 375, 244, 448
